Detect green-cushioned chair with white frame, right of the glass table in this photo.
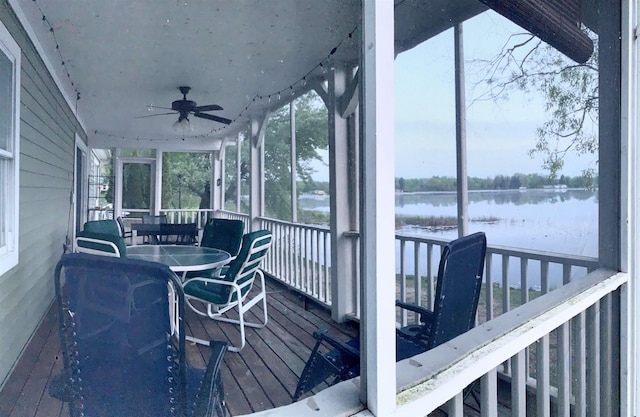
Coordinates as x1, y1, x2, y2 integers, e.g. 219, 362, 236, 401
183, 230, 272, 352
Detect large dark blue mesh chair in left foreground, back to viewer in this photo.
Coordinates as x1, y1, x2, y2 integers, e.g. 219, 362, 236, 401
49, 253, 227, 417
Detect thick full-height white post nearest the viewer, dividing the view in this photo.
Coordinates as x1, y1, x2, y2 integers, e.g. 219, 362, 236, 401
360, 0, 396, 416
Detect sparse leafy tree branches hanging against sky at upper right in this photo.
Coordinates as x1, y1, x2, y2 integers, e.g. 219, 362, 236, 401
476, 28, 598, 178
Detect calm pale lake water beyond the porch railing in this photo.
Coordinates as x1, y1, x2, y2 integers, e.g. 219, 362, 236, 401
299, 189, 598, 287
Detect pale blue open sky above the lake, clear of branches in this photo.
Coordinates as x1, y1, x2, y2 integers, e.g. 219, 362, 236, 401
314, 11, 597, 181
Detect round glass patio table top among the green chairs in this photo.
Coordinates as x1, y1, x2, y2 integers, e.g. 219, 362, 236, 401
127, 245, 231, 281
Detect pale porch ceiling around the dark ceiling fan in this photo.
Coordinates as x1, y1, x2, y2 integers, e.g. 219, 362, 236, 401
10, 0, 485, 148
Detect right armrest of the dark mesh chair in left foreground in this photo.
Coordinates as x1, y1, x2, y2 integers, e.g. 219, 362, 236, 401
193, 340, 227, 417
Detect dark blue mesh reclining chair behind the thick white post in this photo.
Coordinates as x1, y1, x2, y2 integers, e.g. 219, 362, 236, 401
293, 232, 487, 401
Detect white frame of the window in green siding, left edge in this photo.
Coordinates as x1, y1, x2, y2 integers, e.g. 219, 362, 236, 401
0, 22, 22, 275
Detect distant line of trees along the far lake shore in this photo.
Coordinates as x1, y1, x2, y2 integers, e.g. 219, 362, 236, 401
298, 174, 598, 194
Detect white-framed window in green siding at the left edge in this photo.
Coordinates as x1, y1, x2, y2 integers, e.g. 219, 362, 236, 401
0, 23, 20, 275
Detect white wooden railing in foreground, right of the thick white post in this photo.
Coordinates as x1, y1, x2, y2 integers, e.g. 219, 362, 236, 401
398, 270, 628, 417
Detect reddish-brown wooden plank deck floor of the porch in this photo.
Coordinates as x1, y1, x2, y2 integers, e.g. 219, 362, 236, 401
0, 281, 358, 417
